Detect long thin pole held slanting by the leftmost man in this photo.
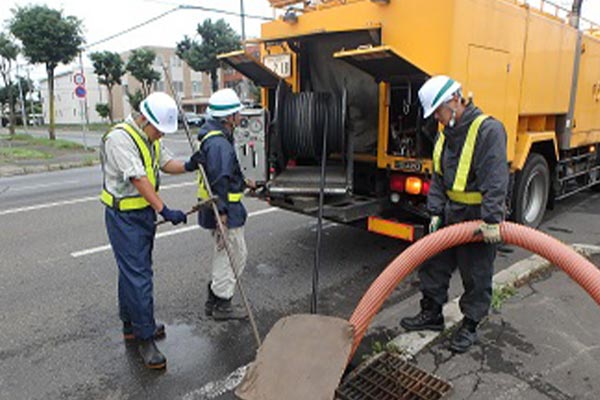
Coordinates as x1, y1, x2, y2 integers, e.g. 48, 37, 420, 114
162, 64, 262, 347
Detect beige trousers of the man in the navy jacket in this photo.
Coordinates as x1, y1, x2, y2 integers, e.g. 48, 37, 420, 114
211, 226, 248, 299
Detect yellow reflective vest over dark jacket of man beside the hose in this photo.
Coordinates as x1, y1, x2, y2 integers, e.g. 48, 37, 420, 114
433, 114, 488, 205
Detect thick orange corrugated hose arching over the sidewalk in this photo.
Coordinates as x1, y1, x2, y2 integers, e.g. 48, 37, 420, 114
350, 221, 600, 358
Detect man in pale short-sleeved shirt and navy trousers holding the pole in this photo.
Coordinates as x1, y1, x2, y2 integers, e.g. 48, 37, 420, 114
100, 92, 197, 369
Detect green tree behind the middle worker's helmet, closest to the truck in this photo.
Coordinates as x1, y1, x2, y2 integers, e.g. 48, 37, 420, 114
177, 19, 240, 92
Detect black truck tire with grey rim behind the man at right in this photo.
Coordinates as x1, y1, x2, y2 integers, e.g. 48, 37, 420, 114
513, 153, 550, 228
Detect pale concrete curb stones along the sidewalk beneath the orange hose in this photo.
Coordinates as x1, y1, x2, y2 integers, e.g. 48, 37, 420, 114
388, 244, 600, 360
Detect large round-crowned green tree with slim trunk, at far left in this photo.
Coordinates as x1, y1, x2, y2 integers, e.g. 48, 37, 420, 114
9, 5, 84, 140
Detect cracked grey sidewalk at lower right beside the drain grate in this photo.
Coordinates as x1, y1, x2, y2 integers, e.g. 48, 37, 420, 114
358, 246, 600, 400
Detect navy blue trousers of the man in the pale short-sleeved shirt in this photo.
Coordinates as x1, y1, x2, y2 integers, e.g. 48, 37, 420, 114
104, 207, 156, 340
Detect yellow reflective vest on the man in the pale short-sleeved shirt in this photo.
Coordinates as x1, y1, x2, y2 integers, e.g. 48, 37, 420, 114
100, 123, 160, 211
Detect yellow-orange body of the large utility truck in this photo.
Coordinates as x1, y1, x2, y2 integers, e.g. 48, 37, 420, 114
224, 0, 600, 238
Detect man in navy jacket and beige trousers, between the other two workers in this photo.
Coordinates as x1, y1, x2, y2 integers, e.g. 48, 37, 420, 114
188, 89, 256, 321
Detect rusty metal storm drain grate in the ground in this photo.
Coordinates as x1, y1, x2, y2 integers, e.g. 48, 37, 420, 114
336, 352, 452, 400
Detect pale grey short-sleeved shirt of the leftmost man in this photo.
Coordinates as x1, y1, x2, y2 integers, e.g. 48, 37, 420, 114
100, 115, 173, 199
